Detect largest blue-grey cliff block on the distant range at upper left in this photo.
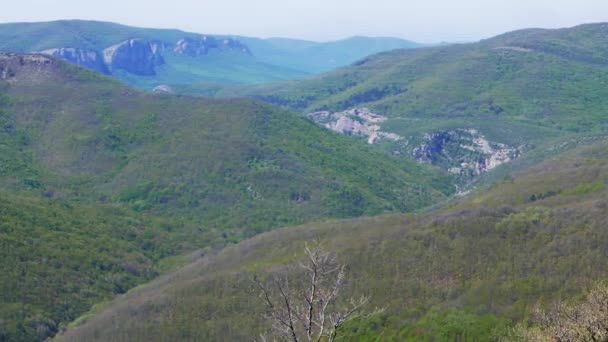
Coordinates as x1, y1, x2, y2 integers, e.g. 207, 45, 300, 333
103, 39, 165, 76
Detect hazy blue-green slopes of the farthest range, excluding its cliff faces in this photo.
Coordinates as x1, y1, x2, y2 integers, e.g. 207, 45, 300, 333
0, 20, 421, 89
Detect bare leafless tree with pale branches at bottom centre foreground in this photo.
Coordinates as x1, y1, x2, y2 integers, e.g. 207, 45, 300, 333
254, 242, 381, 342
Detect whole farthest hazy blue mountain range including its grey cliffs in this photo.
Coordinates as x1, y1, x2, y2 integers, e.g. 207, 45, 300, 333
0, 20, 421, 89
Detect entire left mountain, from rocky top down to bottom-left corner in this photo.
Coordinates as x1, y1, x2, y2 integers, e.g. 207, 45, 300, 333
0, 53, 453, 341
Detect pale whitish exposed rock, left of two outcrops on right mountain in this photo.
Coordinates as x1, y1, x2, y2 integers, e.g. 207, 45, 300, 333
306, 108, 401, 144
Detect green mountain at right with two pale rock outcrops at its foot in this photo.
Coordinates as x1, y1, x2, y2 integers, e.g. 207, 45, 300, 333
239, 23, 608, 183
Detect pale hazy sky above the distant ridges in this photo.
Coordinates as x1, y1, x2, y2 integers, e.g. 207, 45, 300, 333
0, 0, 608, 42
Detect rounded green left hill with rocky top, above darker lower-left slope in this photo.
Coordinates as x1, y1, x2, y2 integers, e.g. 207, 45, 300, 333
0, 54, 452, 234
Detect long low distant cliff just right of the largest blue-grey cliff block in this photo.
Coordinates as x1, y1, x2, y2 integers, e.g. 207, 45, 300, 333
173, 36, 251, 57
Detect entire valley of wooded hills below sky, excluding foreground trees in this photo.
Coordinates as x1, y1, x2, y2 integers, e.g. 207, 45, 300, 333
0, 20, 608, 341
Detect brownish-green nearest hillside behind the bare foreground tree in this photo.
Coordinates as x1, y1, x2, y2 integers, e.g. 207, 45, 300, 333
57, 138, 608, 341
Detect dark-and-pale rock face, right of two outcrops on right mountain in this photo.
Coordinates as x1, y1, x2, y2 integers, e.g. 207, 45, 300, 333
413, 129, 521, 178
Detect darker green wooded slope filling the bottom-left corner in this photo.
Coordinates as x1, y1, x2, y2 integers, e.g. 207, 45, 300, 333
0, 193, 212, 341
